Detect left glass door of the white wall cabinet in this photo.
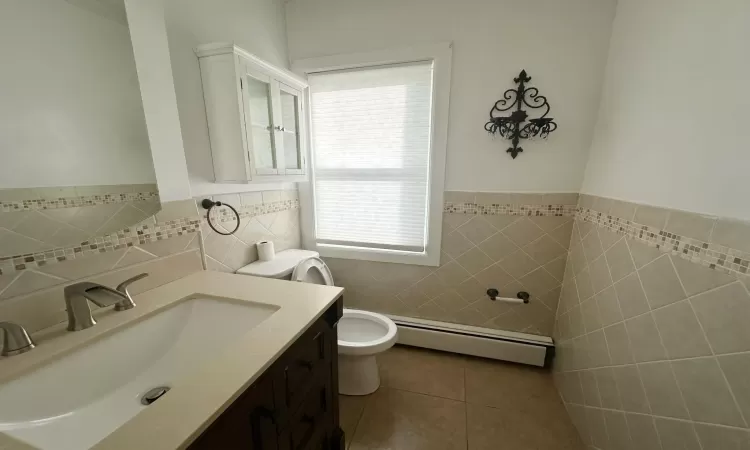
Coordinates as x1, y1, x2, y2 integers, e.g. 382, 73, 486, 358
243, 71, 279, 175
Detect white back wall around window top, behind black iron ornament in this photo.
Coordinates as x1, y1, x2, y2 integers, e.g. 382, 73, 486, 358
286, 0, 615, 192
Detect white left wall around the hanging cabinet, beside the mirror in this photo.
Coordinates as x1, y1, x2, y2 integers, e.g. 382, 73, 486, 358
165, 0, 289, 197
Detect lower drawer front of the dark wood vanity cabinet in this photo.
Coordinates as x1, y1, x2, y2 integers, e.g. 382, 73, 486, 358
279, 371, 332, 450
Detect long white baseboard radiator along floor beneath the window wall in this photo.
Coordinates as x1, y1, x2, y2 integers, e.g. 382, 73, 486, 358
388, 315, 555, 367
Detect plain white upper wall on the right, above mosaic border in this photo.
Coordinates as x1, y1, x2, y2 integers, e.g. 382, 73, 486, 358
583, 0, 750, 219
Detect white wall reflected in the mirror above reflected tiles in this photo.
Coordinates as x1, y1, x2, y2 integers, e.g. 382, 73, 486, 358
0, 0, 155, 188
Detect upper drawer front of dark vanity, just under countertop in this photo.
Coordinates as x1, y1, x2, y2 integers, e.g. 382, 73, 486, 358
274, 320, 333, 422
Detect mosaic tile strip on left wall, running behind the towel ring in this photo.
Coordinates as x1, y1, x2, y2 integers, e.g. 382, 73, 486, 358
0, 200, 299, 275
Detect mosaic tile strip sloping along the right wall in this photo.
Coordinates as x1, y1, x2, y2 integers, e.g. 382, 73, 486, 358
576, 206, 750, 276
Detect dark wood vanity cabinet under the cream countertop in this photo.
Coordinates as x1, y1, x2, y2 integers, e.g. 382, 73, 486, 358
189, 298, 344, 450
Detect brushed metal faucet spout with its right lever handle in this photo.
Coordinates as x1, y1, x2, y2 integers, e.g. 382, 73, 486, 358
65, 273, 148, 331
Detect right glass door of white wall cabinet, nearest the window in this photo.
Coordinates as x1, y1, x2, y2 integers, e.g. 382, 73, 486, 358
279, 83, 304, 175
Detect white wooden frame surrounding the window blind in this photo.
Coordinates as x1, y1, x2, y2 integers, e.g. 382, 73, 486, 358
292, 43, 453, 267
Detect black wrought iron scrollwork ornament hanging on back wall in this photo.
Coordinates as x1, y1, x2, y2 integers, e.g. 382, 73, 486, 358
484, 70, 557, 159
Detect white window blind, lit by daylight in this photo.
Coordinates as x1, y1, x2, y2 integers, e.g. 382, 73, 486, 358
308, 62, 432, 252
